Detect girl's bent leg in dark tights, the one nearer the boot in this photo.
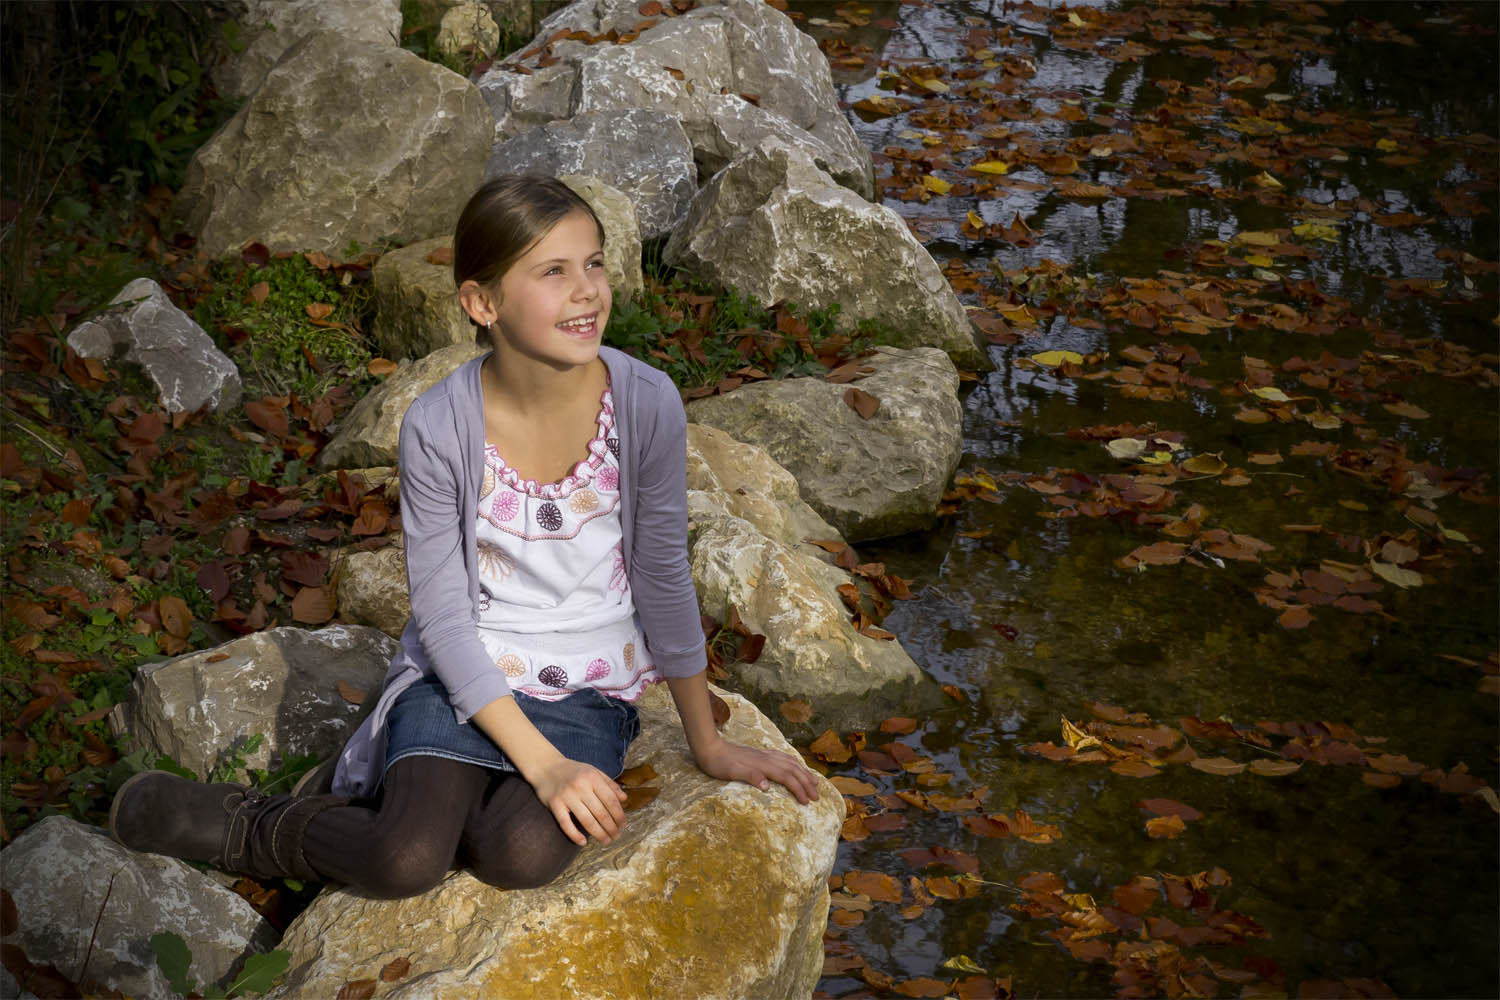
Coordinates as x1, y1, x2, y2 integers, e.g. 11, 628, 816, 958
302, 756, 489, 900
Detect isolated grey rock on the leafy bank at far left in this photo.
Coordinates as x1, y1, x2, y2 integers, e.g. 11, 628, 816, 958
68, 277, 243, 414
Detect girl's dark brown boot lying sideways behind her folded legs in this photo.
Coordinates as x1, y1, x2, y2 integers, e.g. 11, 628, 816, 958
110, 771, 348, 882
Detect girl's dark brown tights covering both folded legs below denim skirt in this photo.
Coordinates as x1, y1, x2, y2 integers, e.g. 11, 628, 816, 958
303, 756, 579, 900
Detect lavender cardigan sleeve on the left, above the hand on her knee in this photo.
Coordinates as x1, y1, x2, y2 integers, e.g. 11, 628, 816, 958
398, 400, 510, 720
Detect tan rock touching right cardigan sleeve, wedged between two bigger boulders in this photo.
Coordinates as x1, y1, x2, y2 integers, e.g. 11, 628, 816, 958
687, 424, 843, 551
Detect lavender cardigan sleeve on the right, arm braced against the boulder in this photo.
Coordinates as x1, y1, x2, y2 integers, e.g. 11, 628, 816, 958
630, 375, 708, 678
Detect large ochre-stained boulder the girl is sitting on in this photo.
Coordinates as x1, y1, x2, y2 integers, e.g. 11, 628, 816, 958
270, 684, 843, 1000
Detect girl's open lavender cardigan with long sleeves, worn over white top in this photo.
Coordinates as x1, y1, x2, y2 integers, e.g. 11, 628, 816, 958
333, 348, 707, 796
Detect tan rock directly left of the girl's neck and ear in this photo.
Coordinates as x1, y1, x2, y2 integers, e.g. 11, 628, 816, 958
374, 235, 474, 358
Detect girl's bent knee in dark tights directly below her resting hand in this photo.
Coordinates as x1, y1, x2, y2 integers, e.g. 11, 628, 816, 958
459, 772, 581, 889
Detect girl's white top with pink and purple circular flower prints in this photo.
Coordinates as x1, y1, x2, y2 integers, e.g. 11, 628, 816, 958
477, 388, 660, 702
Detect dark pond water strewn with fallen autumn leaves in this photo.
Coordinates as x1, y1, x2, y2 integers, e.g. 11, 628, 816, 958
792, 0, 1500, 997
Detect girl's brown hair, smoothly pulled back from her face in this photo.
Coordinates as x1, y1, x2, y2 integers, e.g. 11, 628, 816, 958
453, 174, 605, 343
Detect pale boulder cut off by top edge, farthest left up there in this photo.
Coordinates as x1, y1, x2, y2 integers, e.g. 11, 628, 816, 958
210, 0, 401, 99
